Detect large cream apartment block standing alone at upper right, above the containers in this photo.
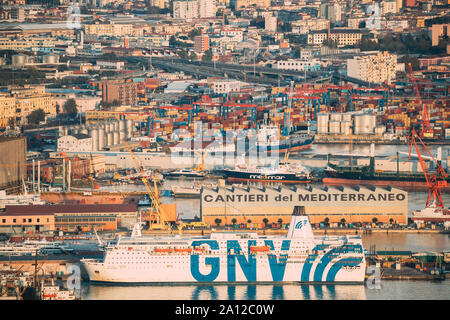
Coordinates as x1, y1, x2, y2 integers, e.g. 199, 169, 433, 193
347, 52, 397, 84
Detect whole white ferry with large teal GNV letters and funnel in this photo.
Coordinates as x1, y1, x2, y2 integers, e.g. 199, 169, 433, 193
81, 207, 366, 284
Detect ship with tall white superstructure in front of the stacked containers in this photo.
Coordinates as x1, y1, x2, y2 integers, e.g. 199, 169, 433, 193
251, 125, 315, 154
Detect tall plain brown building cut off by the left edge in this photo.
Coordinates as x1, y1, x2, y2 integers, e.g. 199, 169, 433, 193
0, 137, 27, 188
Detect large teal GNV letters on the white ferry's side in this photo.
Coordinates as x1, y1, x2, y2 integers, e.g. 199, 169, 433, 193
191, 240, 291, 282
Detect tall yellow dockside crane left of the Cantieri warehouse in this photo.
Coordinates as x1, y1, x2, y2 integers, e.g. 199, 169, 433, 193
126, 144, 172, 230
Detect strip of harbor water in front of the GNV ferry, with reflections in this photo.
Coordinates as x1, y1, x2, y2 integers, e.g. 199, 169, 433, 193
80, 279, 450, 300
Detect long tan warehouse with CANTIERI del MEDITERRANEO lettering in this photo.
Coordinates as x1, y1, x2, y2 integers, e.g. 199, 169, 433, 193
200, 186, 408, 225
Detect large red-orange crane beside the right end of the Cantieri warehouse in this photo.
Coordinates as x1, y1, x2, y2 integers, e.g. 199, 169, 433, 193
405, 128, 448, 211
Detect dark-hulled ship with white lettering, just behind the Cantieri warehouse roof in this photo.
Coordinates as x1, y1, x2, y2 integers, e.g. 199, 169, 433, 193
220, 163, 311, 184
